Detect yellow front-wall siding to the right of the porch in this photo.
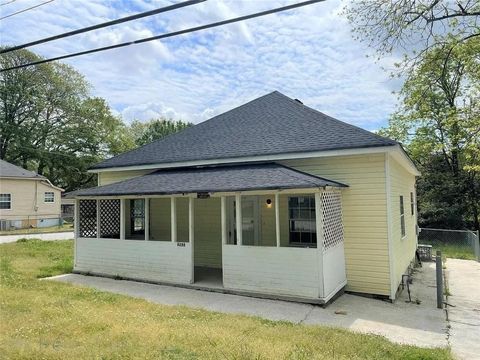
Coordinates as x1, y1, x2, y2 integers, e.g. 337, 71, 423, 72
282, 154, 390, 295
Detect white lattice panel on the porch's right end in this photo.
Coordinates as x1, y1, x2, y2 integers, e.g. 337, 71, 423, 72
322, 191, 343, 251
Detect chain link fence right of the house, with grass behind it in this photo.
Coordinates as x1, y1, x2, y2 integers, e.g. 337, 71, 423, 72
418, 228, 480, 261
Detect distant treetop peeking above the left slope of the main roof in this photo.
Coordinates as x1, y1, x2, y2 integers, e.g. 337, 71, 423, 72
130, 118, 193, 146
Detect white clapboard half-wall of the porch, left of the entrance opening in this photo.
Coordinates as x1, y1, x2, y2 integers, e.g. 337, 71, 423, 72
74, 238, 192, 284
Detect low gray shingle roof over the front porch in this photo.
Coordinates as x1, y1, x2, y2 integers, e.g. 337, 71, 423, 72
66, 163, 346, 197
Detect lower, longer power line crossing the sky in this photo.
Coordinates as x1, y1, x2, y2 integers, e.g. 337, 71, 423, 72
0, 0, 326, 73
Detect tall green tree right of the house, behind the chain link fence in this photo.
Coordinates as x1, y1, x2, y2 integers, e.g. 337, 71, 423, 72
382, 38, 480, 229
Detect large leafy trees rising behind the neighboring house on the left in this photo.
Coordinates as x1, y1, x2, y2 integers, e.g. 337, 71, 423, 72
0, 50, 129, 190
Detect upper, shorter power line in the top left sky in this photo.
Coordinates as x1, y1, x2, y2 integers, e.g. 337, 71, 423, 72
0, 0, 207, 54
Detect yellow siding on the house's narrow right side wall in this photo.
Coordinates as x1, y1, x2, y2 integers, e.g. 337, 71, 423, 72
388, 157, 417, 289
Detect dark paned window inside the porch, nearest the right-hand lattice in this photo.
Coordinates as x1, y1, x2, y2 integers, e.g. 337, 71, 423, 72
288, 196, 317, 246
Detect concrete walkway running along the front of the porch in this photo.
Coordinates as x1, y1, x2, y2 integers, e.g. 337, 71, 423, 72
50, 264, 447, 347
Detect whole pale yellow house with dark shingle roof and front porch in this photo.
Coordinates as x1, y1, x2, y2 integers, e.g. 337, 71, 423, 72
67, 92, 420, 303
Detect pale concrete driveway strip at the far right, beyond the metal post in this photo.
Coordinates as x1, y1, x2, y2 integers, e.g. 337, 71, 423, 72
445, 259, 480, 359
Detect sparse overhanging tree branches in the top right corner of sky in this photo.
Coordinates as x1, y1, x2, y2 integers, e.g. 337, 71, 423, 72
345, 0, 480, 55
